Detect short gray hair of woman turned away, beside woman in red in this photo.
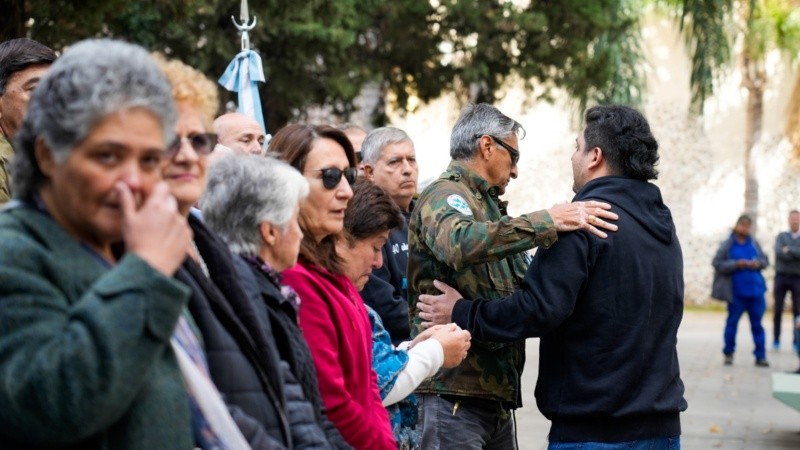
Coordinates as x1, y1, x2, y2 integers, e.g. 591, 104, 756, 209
200, 155, 309, 256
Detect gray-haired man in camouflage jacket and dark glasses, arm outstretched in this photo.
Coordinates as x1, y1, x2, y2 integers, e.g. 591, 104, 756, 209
408, 104, 617, 450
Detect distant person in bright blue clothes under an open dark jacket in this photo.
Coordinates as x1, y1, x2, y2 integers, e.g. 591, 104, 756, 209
711, 215, 769, 367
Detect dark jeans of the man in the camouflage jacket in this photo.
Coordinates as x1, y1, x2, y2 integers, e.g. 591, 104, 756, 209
417, 394, 517, 450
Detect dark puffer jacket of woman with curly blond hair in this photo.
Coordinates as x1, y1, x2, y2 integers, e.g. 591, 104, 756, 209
181, 216, 330, 449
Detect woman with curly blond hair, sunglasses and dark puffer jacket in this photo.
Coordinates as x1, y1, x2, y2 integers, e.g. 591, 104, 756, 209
157, 58, 328, 449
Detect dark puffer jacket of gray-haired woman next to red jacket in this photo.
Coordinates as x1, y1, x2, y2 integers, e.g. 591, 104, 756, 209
235, 257, 352, 450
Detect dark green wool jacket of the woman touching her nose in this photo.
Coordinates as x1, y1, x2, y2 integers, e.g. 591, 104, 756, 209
0, 206, 194, 450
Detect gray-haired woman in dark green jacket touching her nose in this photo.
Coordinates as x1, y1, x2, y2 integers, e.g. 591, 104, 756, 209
0, 40, 202, 449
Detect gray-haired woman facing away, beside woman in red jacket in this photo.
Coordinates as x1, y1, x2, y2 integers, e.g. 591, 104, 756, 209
200, 155, 351, 449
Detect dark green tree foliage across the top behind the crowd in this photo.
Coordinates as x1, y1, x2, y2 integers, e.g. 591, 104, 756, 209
7, 0, 644, 131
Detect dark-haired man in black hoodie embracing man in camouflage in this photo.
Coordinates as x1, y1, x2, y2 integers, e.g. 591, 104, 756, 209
418, 105, 687, 449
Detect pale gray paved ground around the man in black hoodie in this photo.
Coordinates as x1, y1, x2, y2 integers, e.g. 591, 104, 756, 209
517, 312, 800, 450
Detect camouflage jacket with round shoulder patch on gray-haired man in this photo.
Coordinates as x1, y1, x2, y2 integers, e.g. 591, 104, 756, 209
408, 161, 557, 408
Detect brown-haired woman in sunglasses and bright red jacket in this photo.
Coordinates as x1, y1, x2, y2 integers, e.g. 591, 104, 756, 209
268, 124, 397, 450
